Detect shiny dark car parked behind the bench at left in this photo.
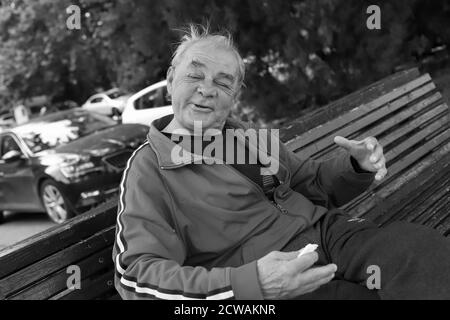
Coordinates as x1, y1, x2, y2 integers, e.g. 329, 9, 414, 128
0, 108, 148, 223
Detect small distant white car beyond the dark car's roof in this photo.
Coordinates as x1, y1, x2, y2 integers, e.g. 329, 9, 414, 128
81, 88, 131, 116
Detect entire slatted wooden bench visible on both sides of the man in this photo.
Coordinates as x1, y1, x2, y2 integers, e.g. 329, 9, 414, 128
0, 69, 450, 299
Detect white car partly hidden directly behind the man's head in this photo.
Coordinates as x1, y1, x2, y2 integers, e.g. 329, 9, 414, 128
122, 80, 173, 126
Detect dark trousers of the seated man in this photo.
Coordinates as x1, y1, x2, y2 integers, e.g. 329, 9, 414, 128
282, 209, 450, 299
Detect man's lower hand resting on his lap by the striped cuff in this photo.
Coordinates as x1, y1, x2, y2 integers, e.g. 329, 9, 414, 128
257, 251, 337, 299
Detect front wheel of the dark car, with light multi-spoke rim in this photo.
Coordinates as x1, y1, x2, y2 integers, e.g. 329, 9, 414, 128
40, 180, 74, 223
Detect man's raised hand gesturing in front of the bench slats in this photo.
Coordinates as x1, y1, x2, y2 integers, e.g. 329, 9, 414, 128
334, 136, 387, 181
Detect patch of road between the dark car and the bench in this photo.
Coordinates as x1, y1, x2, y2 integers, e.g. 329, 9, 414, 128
0, 212, 56, 250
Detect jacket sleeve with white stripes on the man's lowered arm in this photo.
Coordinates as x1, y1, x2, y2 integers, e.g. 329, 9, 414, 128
113, 148, 262, 300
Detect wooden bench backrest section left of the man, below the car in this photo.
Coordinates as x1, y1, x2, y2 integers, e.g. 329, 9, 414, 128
0, 200, 117, 299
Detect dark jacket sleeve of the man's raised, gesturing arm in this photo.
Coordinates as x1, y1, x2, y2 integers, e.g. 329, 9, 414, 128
280, 144, 375, 209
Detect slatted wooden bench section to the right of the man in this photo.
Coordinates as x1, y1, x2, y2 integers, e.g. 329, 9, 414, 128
282, 69, 450, 232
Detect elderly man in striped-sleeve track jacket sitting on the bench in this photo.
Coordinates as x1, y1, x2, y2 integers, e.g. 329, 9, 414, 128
113, 27, 450, 299
